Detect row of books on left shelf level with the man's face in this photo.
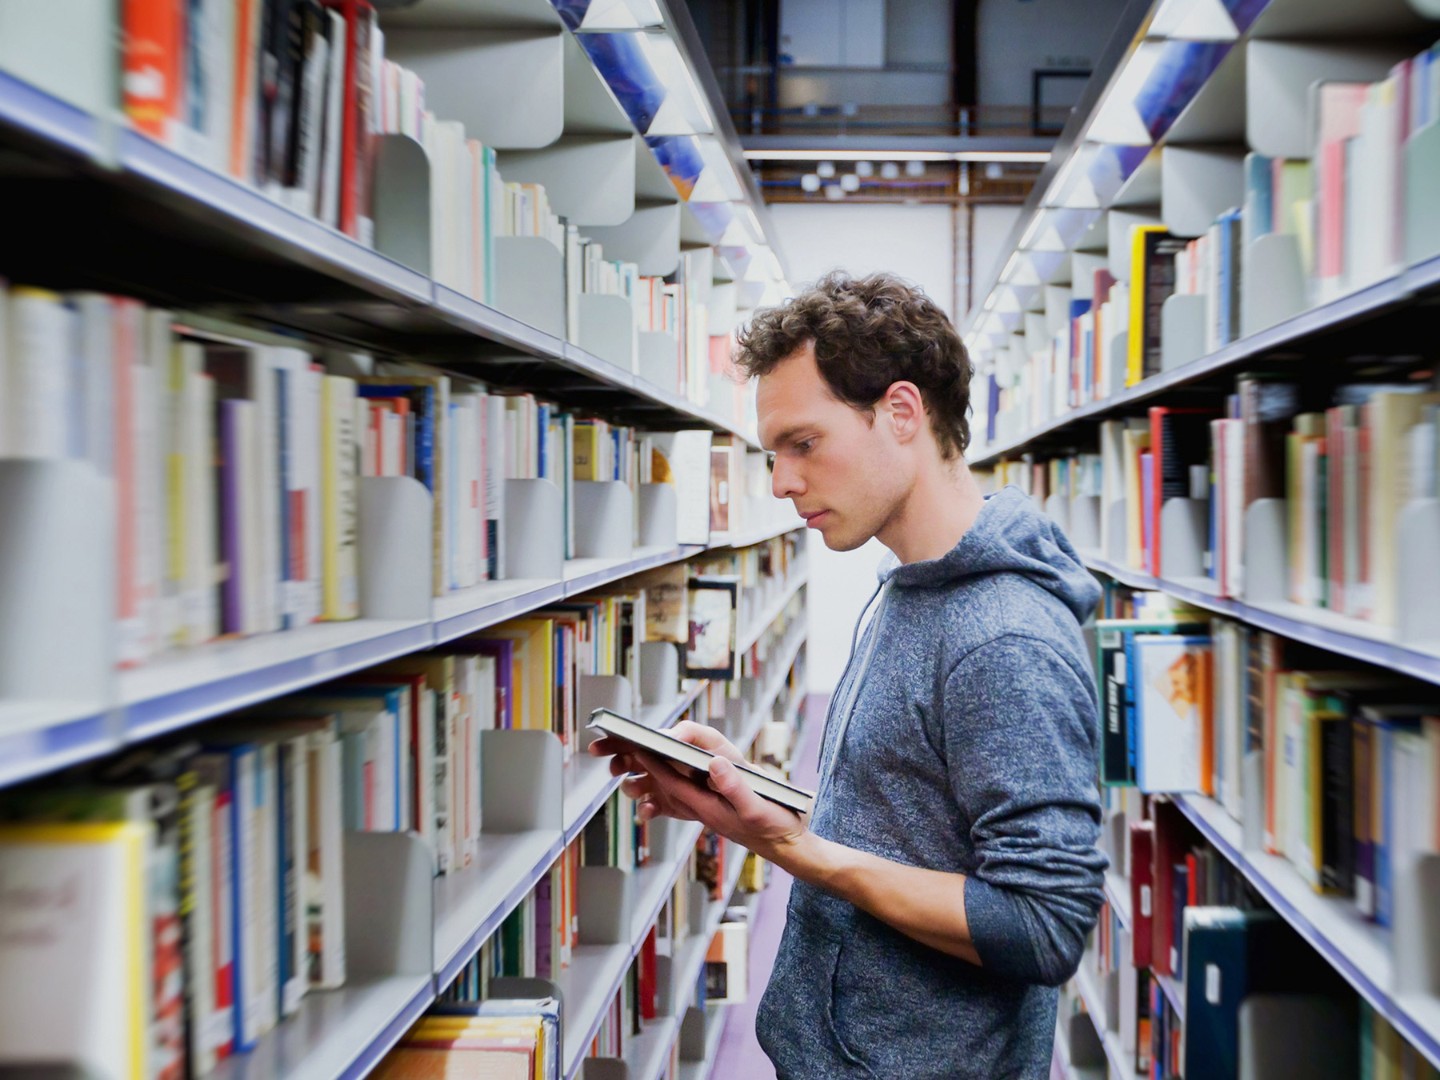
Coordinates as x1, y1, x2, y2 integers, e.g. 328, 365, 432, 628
0, 285, 763, 676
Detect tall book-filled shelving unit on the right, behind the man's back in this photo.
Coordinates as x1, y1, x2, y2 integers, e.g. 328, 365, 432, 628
963, 0, 1440, 1076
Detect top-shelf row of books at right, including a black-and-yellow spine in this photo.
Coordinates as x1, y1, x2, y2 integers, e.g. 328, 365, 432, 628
978, 43, 1440, 452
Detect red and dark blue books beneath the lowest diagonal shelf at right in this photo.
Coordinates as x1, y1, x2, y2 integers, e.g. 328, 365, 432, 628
1081, 798, 1440, 1080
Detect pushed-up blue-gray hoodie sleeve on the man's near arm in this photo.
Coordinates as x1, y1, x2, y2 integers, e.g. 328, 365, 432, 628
945, 634, 1107, 986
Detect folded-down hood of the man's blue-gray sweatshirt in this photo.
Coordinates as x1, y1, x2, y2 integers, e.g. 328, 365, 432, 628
878, 487, 1100, 622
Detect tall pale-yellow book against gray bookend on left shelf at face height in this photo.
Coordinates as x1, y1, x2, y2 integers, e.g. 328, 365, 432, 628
320, 374, 360, 621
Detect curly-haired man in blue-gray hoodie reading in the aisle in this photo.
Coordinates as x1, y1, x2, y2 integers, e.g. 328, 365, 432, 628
595, 274, 1106, 1080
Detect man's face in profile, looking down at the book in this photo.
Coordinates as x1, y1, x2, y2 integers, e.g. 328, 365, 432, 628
756, 344, 906, 552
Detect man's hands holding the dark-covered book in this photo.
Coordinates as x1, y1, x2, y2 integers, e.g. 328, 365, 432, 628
590, 720, 805, 863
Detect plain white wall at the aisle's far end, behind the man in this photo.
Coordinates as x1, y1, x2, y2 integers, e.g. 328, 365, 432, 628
770, 203, 955, 694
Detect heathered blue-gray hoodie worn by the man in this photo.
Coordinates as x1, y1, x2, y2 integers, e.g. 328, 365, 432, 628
756, 488, 1106, 1080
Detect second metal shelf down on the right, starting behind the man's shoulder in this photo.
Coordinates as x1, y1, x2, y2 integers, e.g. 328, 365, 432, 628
1081, 553, 1440, 684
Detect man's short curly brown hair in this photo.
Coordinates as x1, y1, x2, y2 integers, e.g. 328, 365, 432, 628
736, 271, 975, 459
